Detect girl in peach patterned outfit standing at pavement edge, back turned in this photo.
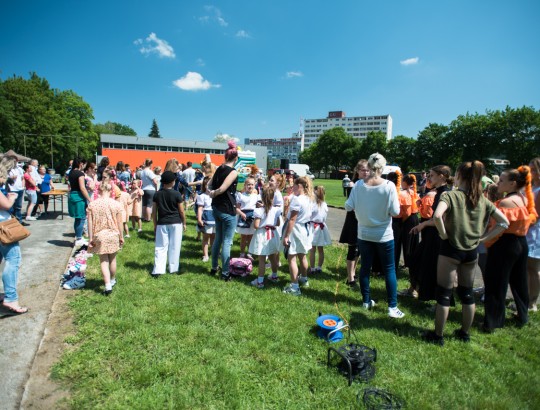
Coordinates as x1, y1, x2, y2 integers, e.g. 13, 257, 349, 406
88, 177, 124, 296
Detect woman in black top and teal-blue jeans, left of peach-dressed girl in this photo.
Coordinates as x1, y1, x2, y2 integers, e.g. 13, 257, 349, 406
68, 158, 90, 241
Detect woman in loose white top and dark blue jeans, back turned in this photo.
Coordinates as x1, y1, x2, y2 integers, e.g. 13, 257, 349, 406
345, 153, 405, 319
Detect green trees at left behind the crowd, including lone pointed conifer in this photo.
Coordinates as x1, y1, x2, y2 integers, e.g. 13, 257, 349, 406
0, 73, 160, 172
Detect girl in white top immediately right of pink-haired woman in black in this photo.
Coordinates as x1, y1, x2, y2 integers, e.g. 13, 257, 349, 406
236, 177, 261, 260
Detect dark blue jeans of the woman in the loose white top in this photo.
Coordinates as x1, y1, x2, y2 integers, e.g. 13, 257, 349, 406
358, 239, 397, 308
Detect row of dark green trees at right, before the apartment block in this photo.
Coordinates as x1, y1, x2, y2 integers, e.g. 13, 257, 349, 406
300, 106, 540, 172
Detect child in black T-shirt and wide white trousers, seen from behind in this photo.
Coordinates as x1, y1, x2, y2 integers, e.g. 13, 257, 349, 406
151, 171, 186, 279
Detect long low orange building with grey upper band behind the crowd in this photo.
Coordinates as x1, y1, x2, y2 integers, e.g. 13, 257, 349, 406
97, 134, 268, 169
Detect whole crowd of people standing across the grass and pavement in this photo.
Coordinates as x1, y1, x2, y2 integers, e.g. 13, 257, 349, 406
0, 146, 540, 345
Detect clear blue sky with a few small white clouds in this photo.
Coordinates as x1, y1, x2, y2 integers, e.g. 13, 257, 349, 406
0, 0, 540, 141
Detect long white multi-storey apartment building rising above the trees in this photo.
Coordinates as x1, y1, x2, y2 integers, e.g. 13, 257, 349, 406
304, 111, 392, 148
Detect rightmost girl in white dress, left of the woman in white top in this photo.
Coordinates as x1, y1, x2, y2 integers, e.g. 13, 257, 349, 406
309, 185, 332, 273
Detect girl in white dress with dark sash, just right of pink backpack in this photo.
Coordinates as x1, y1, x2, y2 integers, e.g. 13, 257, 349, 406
249, 186, 281, 289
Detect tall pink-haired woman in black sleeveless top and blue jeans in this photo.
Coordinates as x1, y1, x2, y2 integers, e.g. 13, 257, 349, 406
208, 141, 238, 280
